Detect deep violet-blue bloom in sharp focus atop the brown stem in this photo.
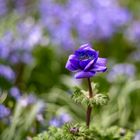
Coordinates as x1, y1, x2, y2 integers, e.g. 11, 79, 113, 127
66, 44, 107, 79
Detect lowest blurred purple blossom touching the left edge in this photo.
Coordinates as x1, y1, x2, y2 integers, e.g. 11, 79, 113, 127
0, 104, 10, 119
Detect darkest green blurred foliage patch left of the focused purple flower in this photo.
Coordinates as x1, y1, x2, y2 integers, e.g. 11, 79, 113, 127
27, 46, 61, 93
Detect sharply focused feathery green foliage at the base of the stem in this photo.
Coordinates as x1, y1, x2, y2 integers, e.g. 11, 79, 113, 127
33, 124, 133, 140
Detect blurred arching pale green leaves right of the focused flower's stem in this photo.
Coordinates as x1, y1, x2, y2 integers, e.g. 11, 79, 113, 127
94, 79, 140, 130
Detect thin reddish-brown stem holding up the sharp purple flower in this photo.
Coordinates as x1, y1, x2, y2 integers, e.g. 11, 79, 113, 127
86, 78, 93, 128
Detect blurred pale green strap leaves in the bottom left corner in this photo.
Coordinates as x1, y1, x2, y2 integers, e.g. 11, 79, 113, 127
0, 98, 43, 140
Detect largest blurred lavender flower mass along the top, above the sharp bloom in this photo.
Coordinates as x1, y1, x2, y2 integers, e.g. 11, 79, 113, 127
39, 0, 131, 49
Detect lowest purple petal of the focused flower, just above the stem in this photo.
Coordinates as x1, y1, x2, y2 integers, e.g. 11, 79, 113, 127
74, 71, 95, 79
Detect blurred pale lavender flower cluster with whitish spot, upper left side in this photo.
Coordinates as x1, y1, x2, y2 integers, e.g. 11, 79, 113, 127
0, 19, 42, 64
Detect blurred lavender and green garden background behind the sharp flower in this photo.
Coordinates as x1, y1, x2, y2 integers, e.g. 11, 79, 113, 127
0, 0, 140, 140
